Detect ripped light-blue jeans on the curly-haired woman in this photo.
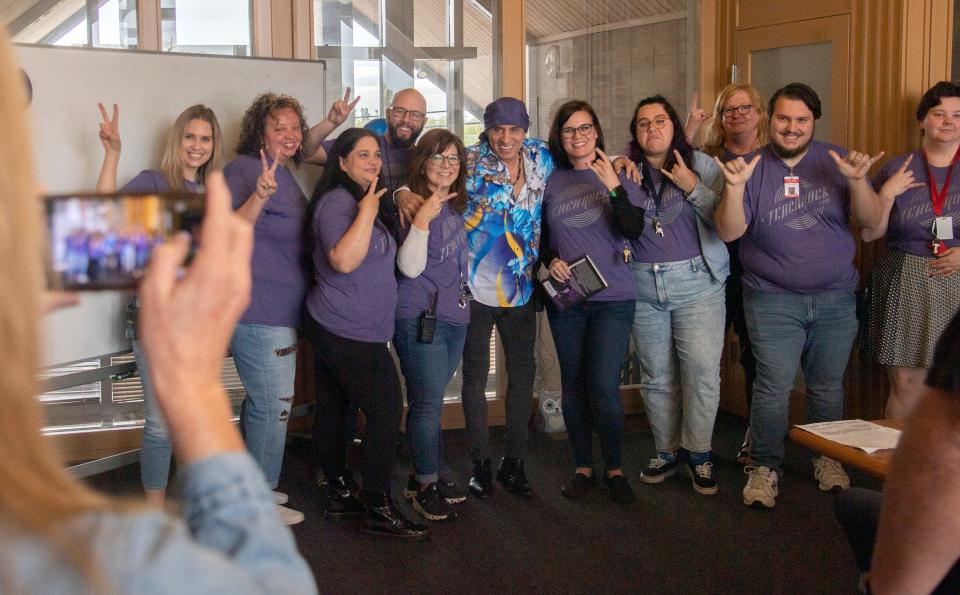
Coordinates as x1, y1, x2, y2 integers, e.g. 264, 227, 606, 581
230, 322, 297, 489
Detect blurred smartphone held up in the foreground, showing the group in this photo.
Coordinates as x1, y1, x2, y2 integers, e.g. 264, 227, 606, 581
44, 193, 204, 291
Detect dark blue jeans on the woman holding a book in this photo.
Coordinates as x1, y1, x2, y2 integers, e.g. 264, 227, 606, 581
547, 301, 635, 471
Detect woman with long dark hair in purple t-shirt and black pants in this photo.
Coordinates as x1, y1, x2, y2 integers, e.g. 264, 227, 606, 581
305, 128, 430, 540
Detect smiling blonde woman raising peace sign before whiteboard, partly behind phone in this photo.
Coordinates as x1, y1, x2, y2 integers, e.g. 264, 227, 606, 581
97, 103, 223, 505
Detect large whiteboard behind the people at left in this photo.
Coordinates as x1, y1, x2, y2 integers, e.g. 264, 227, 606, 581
15, 45, 327, 365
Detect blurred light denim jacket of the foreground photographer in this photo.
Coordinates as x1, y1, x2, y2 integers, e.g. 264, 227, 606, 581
0, 453, 317, 595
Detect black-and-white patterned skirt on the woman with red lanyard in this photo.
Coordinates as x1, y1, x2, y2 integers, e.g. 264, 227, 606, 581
865, 248, 960, 368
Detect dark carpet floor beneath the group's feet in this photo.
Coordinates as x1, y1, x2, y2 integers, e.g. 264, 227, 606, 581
91, 414, 877, 593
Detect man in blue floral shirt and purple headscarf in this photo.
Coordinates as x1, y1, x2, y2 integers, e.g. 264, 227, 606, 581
463, 97, 554, 498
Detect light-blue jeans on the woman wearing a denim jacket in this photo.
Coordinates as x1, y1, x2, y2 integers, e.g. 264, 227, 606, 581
631, 256, 725, 453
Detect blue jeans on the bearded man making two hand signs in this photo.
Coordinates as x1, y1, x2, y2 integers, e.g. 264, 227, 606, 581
743, 290, 857, 471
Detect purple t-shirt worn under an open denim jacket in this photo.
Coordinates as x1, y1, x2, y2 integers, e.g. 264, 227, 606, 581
633, 167, 703, 263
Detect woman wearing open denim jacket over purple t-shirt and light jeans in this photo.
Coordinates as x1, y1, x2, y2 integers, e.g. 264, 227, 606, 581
630, 95, 730, 495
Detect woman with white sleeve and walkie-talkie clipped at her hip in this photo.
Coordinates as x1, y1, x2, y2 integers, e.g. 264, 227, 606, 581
393, 128, 470, 521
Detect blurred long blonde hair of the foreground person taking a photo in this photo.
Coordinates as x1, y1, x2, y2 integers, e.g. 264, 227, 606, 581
0, 35, 114, 584
